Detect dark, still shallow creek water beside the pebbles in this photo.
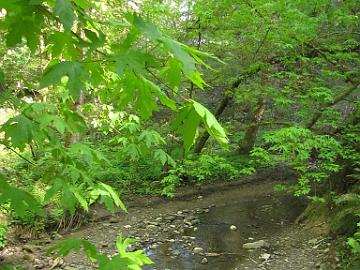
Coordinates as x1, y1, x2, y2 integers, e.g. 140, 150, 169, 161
145, 192, 305, 270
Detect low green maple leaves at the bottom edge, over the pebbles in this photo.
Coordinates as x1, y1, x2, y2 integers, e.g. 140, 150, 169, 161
48, 234, 153, 270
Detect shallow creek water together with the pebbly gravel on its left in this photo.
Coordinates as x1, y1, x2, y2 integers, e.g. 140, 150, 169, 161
59, 182, 305, 270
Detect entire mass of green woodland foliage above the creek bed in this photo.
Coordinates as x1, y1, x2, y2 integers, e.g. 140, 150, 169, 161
0, 0, 360, 268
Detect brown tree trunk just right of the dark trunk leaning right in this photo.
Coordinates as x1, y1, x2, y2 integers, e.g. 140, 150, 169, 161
239, 98, 266, 155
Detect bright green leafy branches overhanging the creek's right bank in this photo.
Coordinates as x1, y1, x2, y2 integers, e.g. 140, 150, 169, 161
251, 127, 343, 196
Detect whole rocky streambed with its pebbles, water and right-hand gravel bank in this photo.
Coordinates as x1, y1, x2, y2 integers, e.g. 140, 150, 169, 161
0, 182, 338, 270
